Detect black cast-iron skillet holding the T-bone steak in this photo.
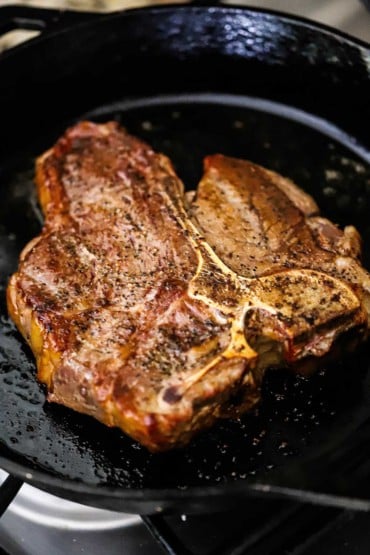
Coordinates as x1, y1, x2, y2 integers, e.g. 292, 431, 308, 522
0, 5, 370, 514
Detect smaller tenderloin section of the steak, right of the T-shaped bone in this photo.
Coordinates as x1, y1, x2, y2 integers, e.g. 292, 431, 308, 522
190, 154, 370, 298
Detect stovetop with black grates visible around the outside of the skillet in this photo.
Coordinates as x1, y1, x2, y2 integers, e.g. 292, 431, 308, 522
0, 0, 370, 555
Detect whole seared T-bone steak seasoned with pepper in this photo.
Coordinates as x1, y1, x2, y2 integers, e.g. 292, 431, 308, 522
7, 122, 370, 451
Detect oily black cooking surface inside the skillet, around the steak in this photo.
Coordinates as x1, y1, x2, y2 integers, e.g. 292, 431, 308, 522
0, 6, 370, 512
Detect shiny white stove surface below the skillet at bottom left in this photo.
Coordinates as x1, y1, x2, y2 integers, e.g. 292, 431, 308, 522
0, 470, 163, 555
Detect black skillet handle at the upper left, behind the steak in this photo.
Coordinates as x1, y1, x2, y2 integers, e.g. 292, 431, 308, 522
0, 6, 102, 37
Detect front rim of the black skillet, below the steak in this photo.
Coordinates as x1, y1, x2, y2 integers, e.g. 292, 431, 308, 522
0, 455, 370, 514
